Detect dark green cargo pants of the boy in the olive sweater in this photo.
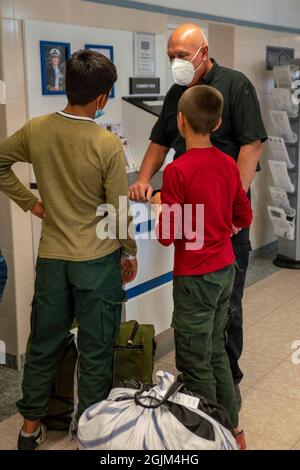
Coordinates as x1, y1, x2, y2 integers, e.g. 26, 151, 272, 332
17, 250, 125, 421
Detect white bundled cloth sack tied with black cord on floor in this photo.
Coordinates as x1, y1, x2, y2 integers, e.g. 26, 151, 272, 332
77, 371, 237, 450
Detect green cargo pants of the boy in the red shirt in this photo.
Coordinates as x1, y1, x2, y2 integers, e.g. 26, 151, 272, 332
172, 265, 238, 427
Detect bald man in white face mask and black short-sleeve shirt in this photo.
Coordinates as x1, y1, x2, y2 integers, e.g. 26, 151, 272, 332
129, 24, 267, 404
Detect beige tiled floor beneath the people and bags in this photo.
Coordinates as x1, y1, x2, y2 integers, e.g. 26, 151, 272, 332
0, 264, 300, 450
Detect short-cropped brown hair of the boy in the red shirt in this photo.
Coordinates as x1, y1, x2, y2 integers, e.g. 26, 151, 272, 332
178, 85, 224, 135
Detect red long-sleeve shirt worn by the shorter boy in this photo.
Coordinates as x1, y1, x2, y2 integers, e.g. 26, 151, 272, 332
157, 147, 252, 276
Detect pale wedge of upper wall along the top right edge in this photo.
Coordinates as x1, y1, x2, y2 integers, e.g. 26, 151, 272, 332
138, 0, 300, 28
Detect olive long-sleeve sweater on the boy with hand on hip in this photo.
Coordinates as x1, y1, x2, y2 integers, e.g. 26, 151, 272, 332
0, 113, 136, 261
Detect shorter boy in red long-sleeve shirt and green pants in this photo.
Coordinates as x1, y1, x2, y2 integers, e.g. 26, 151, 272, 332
157, 85, 252, 444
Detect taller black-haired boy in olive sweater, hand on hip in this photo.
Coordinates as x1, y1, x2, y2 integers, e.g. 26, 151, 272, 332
0, 51, 137, 450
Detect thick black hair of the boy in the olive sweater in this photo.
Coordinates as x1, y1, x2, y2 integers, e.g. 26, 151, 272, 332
66, 49, 118, 106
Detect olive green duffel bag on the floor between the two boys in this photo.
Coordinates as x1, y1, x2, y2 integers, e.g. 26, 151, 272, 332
113, 320, 155, 384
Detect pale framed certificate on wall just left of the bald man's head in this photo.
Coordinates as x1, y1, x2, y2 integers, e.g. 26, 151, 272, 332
133, 33, 156, 77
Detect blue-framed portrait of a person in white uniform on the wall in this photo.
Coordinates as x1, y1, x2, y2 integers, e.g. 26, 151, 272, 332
40, 41, 71, 95
